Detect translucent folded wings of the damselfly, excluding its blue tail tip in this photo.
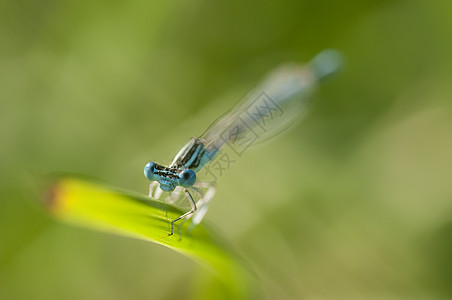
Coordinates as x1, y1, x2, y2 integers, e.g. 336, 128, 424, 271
200, 65, 316, 151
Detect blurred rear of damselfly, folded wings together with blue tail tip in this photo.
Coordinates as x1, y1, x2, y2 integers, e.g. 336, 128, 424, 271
199, 50, 342, 181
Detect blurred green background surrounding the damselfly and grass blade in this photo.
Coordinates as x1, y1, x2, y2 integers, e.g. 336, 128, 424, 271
0, 0, 452, 299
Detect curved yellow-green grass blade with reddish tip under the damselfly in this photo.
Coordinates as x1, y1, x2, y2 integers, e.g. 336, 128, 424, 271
45, 175, 249, 299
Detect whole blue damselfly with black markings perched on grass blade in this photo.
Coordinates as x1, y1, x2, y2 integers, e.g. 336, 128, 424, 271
144, 49, 342, 235
